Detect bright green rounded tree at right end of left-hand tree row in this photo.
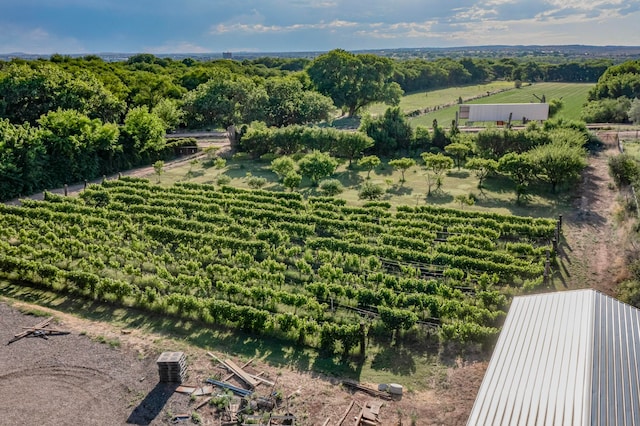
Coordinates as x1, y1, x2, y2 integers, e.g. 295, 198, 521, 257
123, 106, 166, 153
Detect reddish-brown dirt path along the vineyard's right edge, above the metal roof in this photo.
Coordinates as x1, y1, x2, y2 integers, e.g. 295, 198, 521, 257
559, 132, 627, 296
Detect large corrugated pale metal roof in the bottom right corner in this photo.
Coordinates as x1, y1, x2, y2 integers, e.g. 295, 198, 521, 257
468, 290, 640, 426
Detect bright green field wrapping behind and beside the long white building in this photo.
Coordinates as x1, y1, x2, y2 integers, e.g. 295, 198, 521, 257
410, 83, 593, 127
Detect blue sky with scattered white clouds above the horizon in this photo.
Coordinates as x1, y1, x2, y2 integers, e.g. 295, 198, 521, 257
0, 0, 640, 54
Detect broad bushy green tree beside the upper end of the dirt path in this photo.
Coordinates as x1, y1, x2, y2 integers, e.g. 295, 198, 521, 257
528, 140, 587, 192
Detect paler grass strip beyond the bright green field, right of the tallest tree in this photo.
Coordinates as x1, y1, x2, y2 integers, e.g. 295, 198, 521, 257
368, 81, 514, 115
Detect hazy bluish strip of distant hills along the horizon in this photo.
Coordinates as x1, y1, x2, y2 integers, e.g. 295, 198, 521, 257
0, 45, 640, 62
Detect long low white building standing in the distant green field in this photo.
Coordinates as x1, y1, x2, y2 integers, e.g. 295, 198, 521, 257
458, 103, 549, 123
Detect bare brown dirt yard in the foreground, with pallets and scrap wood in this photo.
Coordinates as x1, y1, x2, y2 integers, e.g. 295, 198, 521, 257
0, 302, 486, 426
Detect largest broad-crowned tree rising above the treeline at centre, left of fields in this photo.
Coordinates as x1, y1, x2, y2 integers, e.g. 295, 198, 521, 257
307, 49, 403, 117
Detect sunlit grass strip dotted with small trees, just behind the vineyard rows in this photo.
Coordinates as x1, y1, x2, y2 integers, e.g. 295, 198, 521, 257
158, 153, 570, 217
